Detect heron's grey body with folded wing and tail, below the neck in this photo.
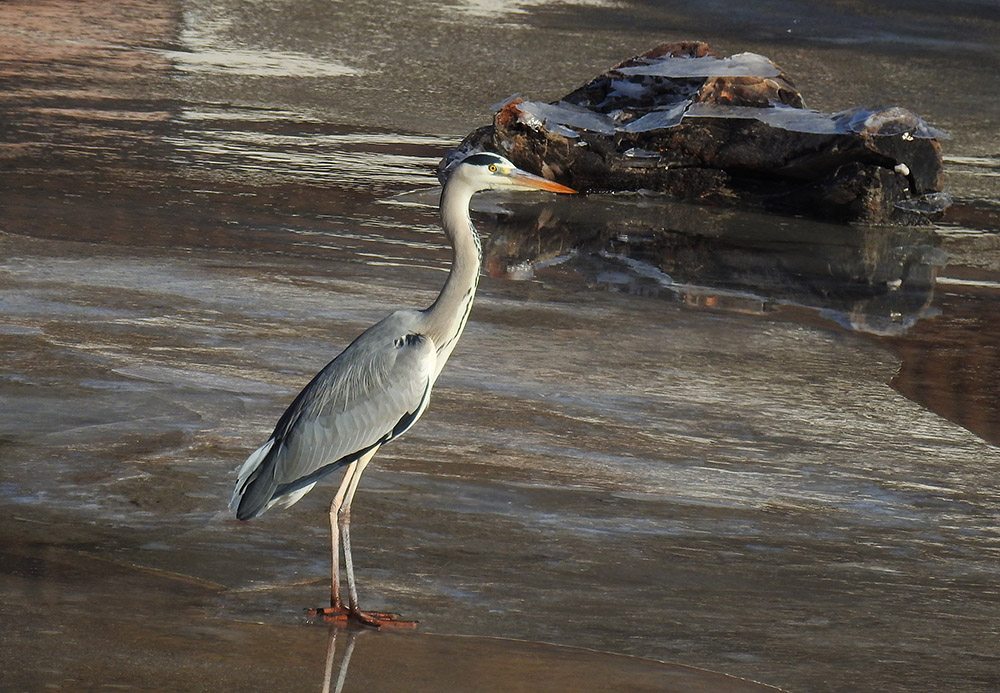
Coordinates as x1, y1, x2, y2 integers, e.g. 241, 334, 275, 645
233, 313, 437, 519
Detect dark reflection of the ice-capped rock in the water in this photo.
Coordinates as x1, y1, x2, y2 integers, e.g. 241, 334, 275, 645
472, 196, 947, 335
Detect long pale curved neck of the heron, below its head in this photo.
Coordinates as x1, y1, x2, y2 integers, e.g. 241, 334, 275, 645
425, 180, 482, 377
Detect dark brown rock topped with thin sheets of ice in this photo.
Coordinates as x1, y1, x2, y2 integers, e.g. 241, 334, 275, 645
440, 42, 947, 224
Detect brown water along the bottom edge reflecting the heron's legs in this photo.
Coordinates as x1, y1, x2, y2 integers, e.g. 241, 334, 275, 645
0, 536, 777, 693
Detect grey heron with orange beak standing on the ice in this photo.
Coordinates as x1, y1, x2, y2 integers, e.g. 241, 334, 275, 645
231, 153, 576, 626
